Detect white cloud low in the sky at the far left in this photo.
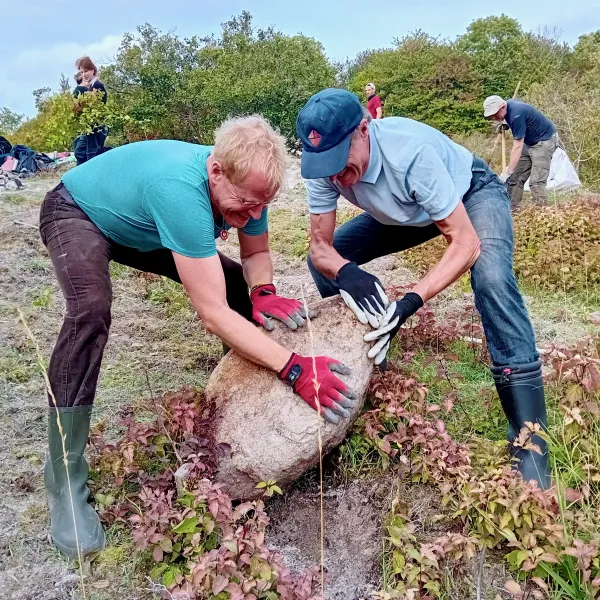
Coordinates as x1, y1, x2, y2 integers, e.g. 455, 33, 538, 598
0, 35, 122, 116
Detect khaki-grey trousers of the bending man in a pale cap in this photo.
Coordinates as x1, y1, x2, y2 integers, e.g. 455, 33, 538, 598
506, 135, 558, 209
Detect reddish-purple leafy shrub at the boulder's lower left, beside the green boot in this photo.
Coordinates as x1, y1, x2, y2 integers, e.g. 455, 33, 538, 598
91, 389, 320, 600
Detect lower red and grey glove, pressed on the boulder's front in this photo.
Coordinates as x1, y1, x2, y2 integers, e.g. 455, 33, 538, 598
279, 353, 356, 424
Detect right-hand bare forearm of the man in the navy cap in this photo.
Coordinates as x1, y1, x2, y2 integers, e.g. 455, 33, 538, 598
412, 238, 481, 302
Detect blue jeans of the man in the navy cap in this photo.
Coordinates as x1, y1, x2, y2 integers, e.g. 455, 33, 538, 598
308, 159, 539, 367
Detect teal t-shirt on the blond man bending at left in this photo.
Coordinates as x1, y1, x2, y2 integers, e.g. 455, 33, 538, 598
62, 140, 267, 258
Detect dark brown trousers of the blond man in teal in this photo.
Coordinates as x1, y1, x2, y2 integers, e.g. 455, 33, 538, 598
40, 183, 252, 407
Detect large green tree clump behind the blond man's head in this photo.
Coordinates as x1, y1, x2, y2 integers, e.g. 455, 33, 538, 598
101, 11, 335, 144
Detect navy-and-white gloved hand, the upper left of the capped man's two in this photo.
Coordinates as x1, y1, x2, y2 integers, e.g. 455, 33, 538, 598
336, 263, 390, 327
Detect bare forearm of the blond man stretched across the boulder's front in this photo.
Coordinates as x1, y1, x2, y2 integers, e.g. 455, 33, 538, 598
204, 306, 292, 372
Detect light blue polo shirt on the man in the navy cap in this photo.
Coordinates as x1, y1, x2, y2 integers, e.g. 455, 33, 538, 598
305, 117, 473, 227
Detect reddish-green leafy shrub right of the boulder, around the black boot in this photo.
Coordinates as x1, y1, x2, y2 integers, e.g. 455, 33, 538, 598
348, 307, 600, 600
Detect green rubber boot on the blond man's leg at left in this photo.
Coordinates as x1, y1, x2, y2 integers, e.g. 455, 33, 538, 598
44, 406, 104, 558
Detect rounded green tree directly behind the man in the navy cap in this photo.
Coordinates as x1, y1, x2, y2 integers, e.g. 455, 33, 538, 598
349, 31, 486, 133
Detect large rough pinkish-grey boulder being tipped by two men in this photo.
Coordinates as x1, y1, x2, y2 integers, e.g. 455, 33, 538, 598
206, 296, 373, 500
